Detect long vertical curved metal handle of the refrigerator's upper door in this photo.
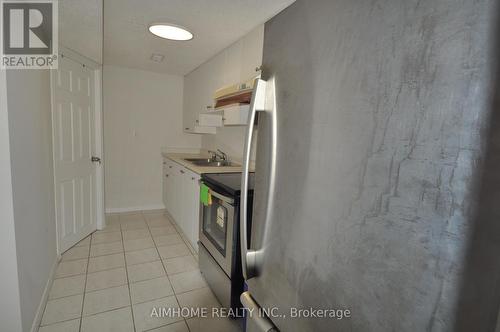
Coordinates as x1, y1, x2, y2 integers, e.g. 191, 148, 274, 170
240, 78, 266, 279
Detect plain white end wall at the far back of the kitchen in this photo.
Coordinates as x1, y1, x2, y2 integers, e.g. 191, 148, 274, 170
103, 66, 201, 211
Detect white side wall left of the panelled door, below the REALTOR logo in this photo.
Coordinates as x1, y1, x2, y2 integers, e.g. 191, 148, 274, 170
7, 70, 57, 331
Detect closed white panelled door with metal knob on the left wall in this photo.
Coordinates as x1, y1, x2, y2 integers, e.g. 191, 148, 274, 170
52, 56, 98, 253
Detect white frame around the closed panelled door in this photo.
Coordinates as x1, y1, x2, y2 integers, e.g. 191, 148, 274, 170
50, 45, 106, 255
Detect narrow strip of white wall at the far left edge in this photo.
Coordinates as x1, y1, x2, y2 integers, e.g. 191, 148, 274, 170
0, 70, 22, 332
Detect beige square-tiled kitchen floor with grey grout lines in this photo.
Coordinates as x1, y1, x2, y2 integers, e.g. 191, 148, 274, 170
39, 211, 241, 332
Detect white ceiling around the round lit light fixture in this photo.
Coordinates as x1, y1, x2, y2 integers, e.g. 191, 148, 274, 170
103, 0, 295, 75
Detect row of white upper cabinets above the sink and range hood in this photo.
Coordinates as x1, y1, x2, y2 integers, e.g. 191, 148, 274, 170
183, 25, 264, 133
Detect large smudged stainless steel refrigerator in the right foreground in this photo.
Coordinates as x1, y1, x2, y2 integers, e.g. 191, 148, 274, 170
240, 0, 500, 332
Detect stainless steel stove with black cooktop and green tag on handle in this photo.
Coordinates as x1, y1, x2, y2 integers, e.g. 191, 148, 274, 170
198, 173, 253, 309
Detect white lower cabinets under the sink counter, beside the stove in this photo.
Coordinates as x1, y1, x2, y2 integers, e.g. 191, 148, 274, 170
163, 159, 200, 250
